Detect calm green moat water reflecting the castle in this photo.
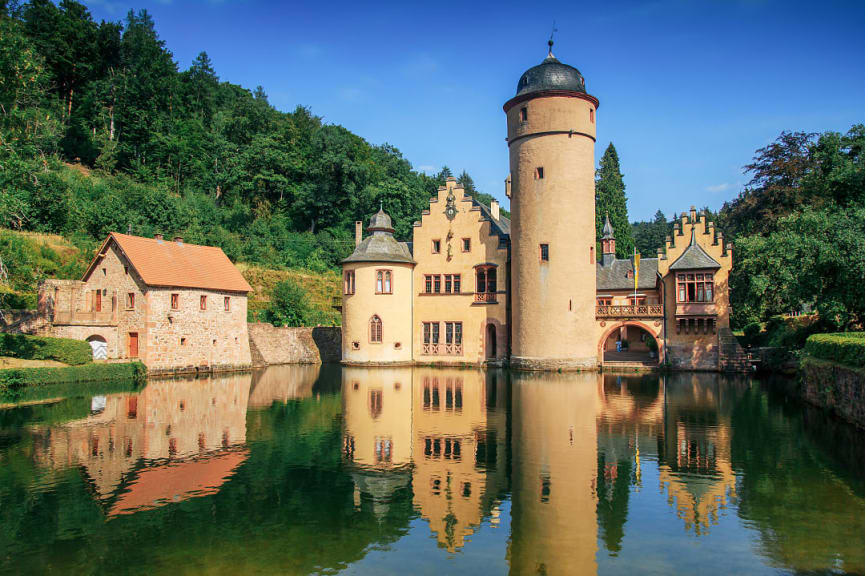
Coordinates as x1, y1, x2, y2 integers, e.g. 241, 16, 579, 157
0, 366, 865, 575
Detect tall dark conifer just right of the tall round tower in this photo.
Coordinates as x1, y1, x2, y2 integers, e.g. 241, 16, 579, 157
595, 142, 634, 258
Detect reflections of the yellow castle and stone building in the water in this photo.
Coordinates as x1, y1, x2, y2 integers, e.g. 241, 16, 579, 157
25, 366, 747, 573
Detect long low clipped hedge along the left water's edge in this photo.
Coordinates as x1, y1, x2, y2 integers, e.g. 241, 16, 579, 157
0, 362, 147, 394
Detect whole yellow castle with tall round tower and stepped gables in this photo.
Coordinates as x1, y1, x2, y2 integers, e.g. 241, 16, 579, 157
342, 45, 744, 370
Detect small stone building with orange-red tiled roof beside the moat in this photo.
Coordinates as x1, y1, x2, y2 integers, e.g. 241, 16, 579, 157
39, 233, 252, 372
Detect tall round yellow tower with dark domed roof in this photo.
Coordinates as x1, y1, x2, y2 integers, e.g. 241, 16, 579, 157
504, 42, 598, 370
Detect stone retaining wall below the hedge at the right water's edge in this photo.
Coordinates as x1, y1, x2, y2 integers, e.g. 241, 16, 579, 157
800, 358, 865, 428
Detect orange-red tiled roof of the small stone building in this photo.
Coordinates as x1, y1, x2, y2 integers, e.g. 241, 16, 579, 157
84, 232, 252, 292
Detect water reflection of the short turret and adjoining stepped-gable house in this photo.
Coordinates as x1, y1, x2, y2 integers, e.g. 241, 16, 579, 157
343, 368, 508, 552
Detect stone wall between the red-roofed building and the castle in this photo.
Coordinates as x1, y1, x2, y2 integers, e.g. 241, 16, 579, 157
249, 323, 342, 366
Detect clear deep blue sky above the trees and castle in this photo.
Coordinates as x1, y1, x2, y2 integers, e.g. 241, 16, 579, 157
85, 0, 865, 220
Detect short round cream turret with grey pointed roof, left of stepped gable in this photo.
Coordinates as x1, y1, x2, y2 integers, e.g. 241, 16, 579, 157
342, 210, 415, 364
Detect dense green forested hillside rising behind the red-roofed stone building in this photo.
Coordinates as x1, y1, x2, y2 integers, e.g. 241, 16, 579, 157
0, 0, 500, 270
